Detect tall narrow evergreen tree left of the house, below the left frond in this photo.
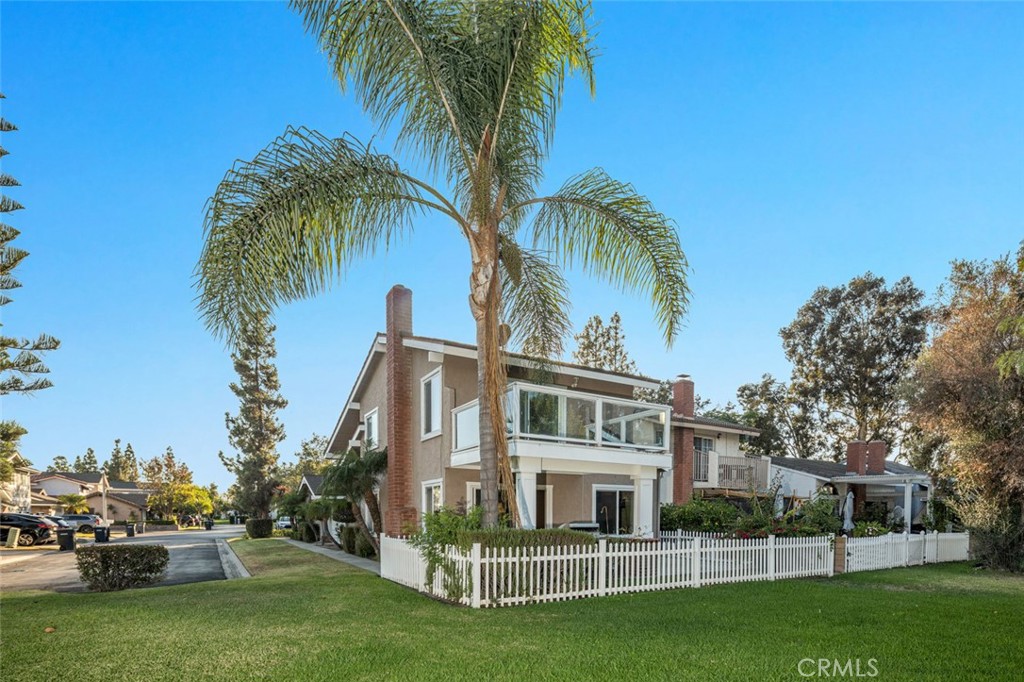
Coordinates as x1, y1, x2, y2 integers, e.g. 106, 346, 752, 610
219, 314, 288, 518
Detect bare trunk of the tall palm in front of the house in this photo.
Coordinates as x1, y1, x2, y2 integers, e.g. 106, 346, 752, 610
469, 223, 519, 527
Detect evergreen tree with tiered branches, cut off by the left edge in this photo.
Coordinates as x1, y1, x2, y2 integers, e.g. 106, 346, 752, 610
0, 93, 60, 395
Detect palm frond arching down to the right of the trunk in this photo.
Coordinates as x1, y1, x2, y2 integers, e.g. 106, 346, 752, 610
509, 164, 689, 345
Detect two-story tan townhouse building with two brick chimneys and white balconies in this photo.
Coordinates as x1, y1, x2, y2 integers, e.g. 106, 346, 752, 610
328, 286, 768, 536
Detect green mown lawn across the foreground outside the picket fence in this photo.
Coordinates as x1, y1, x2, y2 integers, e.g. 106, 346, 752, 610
0, 540, 1024, 682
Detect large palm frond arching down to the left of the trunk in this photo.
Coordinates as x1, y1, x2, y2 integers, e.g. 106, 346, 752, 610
196, 128, 458, 340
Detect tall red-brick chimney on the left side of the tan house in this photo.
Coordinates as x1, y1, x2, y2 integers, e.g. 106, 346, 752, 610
383, 285, 416, 536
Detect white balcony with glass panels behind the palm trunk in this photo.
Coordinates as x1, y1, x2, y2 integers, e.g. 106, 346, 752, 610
452, 382, 671, 466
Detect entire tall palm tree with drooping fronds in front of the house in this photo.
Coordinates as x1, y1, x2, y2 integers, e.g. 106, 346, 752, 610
196, 0, 689, 525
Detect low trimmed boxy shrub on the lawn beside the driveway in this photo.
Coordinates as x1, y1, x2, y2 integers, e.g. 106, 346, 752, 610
75, 545, 170, 592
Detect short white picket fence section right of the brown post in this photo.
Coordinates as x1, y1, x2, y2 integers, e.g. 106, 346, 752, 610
846, 531, 971, 572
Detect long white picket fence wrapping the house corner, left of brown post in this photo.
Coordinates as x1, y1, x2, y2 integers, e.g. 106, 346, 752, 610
381, 536, 835, 608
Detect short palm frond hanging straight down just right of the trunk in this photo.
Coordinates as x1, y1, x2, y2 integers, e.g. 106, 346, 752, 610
499, 235, 572, 359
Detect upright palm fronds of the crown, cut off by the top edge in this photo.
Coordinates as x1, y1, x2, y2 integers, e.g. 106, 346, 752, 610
291, 0, 594, 213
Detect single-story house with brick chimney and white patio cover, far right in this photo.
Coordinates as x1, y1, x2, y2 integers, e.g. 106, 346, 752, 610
771, 440, 933, 528
